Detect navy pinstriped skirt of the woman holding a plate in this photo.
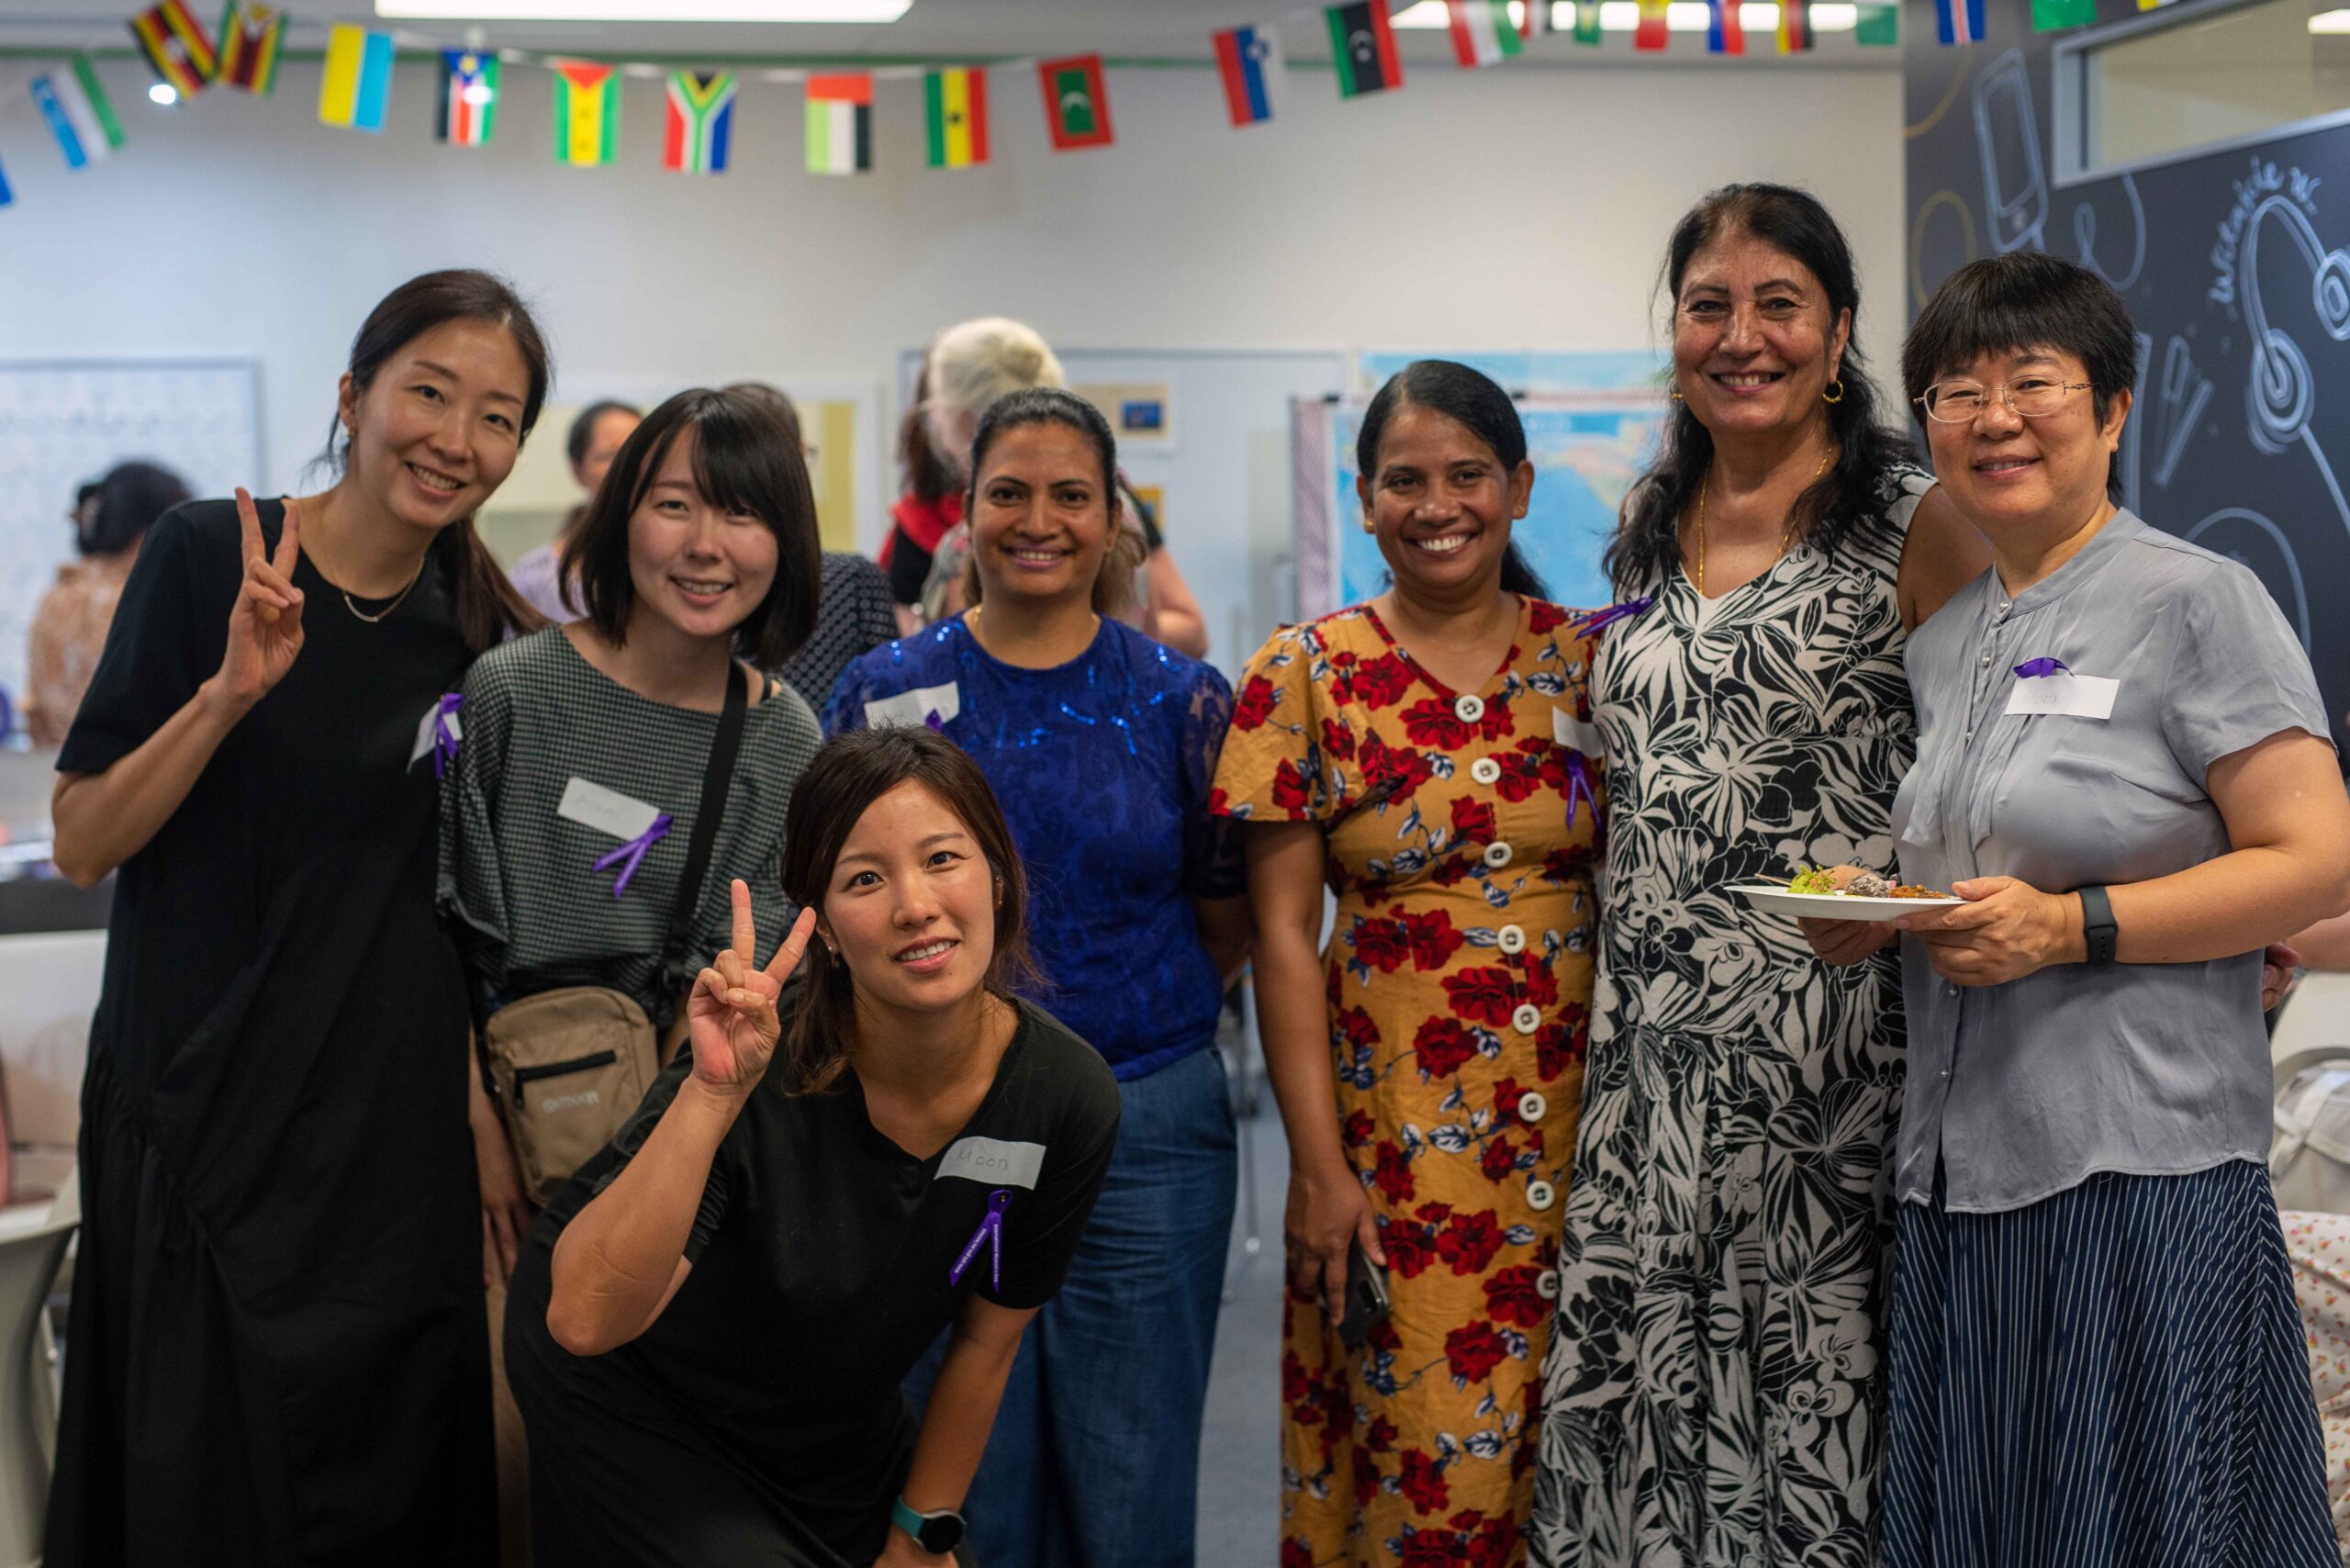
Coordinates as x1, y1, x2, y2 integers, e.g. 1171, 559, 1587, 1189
1885, 1161, 2343, 1568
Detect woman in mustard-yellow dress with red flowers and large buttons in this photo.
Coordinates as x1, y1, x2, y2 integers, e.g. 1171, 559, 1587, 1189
1210, 360, 1600, 1568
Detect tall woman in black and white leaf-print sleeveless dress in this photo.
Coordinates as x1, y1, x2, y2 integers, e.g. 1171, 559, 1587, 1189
1530, 185, 1986, 1568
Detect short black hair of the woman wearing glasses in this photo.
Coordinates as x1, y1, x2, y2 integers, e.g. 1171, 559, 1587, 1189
1901, 252, 2139, 500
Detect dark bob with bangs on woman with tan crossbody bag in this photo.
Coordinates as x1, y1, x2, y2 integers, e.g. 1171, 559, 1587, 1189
564, 388, 822, 670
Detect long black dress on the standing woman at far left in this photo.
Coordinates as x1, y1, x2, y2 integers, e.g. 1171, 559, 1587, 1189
47, 500, 496, 1568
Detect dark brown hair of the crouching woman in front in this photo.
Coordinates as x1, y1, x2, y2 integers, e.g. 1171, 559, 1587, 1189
778, 726, 1041, 1093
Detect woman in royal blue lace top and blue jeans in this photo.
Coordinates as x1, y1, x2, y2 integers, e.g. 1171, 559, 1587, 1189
825, 388, 1248, 1568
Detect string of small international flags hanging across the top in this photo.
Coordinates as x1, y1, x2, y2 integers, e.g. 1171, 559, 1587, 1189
0, 0, 1917, 207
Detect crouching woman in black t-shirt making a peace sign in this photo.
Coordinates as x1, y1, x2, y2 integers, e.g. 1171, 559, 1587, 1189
505, 729, 1119, 1568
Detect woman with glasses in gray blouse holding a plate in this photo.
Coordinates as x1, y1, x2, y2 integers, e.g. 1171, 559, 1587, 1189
1805, 252, 2350, 1568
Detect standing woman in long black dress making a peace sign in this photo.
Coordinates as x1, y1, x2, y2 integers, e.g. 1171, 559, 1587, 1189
47, 273, 547, 1568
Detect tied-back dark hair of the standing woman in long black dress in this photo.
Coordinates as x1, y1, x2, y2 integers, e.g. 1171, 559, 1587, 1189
327, 268, 554, 654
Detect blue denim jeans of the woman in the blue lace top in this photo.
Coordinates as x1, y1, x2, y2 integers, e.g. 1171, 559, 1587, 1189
905, 1048, 1241, 1568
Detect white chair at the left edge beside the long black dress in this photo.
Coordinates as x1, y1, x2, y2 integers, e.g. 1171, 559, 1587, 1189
0, 1204, 75, 1568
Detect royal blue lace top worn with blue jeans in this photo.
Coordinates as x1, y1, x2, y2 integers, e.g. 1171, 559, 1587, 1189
825, 616, 1248, 1081
